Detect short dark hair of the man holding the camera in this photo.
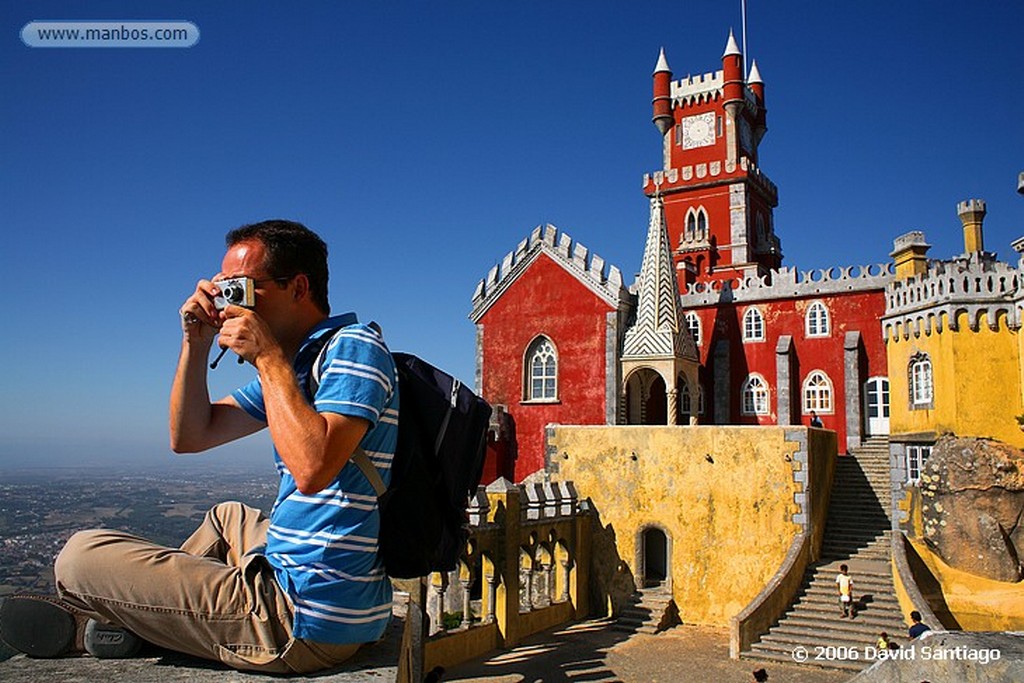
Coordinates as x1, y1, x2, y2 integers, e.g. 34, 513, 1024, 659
224, 220, 331, 313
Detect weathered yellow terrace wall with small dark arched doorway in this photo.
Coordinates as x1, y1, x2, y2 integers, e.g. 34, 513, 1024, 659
547, 426, 835, 626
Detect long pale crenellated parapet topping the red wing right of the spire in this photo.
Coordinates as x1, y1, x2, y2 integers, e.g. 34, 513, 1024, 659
679, 263, 893, 308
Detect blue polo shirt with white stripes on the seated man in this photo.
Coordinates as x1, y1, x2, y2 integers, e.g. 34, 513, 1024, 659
231, 313, 398, 643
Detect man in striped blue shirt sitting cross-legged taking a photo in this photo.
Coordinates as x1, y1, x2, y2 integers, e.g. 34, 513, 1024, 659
0, 220, 399, 673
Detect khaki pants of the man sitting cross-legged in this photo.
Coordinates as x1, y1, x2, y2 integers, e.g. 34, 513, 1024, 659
54, 503, 359, 673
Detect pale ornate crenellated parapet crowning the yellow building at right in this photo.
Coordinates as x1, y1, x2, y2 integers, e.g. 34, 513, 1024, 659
882, 254, 1024, 341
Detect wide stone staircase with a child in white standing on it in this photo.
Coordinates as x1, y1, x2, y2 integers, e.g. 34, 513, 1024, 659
741, 438, 906, 671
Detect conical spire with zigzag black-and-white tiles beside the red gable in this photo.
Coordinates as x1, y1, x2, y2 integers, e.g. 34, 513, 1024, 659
623, 196, 697, 358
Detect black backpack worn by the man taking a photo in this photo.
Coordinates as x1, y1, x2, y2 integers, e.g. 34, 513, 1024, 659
309, 334, 490, 579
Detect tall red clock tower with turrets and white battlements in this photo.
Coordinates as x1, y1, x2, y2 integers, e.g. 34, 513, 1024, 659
644, 32, 782, 288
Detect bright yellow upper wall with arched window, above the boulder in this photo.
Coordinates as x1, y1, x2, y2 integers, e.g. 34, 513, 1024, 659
886, 312, 1024, 447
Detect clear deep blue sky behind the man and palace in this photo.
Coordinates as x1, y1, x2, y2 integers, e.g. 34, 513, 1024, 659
0, 0, 1024, 470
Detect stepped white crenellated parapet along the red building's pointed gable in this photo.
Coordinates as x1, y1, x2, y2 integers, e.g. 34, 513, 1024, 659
469, 223, 630, 323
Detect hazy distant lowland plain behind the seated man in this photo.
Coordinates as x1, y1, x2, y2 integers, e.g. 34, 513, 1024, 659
0, 468, 278, 597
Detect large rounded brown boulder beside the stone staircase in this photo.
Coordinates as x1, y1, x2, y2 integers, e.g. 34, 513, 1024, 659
921, 436, 1024, 582
